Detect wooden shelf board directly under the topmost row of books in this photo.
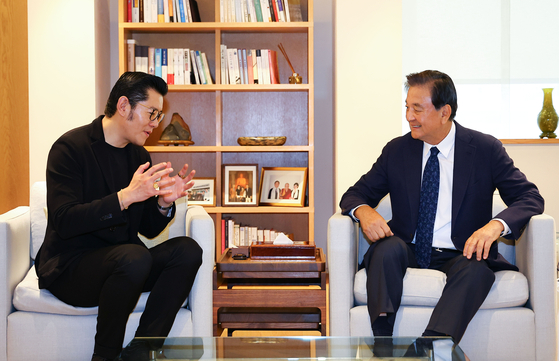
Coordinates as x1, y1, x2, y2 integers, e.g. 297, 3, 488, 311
119, 22, 313, 33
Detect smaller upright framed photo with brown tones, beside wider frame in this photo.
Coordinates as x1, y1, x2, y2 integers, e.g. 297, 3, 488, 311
221, 164, 258, 206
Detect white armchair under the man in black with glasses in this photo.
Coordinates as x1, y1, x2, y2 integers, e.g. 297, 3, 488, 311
0, 182, 215, 361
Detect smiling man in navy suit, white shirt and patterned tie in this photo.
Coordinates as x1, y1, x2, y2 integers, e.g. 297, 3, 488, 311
340, 71, 544, 343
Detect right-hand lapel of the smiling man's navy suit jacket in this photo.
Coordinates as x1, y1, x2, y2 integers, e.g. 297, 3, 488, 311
452, 123, 476, 228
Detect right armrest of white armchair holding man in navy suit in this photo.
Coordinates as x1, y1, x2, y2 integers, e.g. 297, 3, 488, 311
516, 214, 557, 360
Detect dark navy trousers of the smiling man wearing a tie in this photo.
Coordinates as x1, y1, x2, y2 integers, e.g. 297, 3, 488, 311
363, 236, 495, 342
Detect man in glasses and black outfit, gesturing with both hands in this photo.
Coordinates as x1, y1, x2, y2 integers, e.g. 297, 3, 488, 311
35, 72, 202, 361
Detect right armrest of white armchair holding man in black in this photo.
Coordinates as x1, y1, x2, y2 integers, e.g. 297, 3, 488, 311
185, 206, 215, 336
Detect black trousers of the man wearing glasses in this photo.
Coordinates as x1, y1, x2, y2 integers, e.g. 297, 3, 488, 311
48, 237, 202, 359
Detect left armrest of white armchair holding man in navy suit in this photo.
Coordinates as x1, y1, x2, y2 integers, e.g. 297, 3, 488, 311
327, 212, 358, 336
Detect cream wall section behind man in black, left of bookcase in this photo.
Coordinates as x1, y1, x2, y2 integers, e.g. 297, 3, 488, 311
28, 0, 109, 184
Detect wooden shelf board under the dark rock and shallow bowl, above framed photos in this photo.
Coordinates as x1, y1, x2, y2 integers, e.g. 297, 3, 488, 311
144, 145, 313, 153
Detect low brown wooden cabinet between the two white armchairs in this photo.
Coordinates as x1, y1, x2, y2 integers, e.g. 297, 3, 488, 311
213, 248, 328, 336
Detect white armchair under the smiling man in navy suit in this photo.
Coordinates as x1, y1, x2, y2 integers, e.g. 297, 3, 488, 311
327, 195, 557, 361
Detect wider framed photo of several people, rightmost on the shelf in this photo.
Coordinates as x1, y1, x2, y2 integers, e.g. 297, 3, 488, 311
260, 167, 307, 207
